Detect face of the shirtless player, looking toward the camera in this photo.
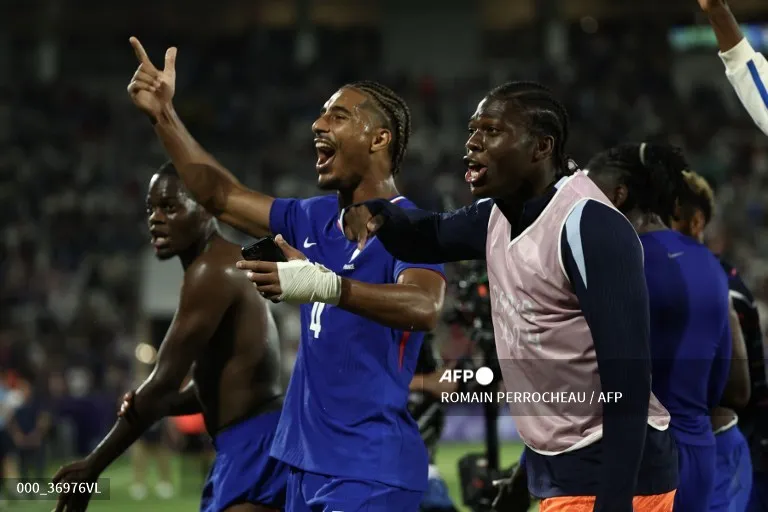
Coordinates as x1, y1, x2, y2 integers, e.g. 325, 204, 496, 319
147, 174, 209, 260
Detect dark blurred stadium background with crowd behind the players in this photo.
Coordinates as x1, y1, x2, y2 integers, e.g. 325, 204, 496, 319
0, 0, 768, 511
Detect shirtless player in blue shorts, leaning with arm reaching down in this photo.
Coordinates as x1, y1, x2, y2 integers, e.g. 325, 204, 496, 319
54, 164, 289, 512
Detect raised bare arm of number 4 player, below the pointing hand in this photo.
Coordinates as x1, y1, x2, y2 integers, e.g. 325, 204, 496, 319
155, 105, 274, 237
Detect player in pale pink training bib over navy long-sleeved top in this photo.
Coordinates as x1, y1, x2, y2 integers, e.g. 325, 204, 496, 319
345, 82, 677, 512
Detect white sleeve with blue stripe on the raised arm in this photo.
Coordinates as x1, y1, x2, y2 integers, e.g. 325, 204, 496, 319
720, 38, 768, 135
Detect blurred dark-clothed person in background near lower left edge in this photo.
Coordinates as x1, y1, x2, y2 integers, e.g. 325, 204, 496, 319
8, 375, 51, 486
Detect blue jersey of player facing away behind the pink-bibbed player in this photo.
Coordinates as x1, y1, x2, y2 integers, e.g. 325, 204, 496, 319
640, 230, 731, 446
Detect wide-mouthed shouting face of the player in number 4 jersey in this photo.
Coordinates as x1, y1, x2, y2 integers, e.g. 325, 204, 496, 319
312, 87, 382, 190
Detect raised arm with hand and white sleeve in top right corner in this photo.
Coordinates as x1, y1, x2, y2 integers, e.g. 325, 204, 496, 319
699, 0, 768, 135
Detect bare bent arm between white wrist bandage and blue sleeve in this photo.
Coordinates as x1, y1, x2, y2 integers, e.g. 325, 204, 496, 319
339, 268, 445, 331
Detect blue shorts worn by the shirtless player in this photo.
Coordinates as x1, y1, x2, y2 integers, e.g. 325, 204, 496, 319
200, 411, 289, 512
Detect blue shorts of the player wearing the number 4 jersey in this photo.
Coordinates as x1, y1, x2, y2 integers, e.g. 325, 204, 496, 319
285, 468, 424, 512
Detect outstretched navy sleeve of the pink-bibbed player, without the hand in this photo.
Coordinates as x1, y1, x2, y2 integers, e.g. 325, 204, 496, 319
352, 199, 493, 263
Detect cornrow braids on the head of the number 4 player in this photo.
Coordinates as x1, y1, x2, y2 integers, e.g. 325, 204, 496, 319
346, 81, 411, 174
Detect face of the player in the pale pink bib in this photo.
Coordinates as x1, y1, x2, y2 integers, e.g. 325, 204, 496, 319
464, 98, 536, 198
